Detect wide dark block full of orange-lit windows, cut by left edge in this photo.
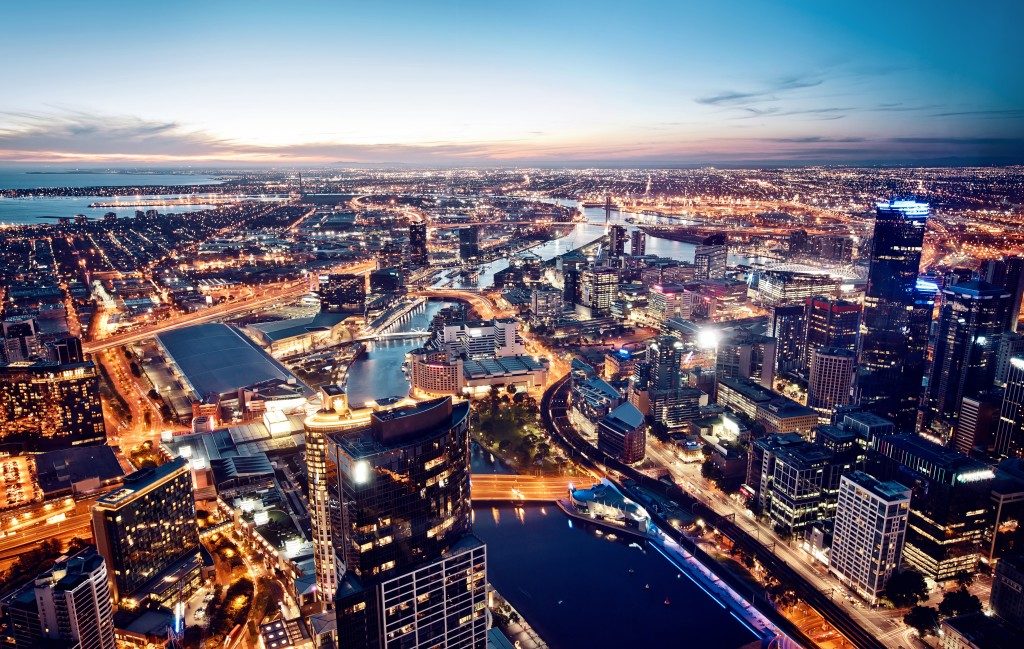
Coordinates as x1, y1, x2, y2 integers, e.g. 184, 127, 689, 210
0, 360, 106, 451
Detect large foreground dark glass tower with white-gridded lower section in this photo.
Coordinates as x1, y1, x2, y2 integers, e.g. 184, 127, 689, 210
326, 397, 487, 649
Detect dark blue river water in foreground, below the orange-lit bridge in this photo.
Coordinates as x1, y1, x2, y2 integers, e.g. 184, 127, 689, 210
473, 506, 756, 649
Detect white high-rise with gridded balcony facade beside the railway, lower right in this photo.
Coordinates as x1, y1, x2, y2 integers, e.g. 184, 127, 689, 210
828, 471, 910, 605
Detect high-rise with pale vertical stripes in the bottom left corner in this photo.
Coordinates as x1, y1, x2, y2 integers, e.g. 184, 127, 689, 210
7, 546, 116, 649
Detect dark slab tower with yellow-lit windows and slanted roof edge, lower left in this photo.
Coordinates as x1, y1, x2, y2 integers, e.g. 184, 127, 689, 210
92, 458, 203, 608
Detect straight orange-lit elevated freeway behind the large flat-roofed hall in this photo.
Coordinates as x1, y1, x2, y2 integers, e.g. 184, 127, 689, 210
82, 260, 377, 353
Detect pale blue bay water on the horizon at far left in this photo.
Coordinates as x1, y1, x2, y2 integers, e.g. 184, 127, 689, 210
0, 169, 220, 225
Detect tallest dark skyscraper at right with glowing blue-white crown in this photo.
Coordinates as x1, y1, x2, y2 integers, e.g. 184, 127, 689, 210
857, 200, 929, 430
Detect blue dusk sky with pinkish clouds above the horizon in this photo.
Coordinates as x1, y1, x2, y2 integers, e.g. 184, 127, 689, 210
0, 0, 1024, 167
